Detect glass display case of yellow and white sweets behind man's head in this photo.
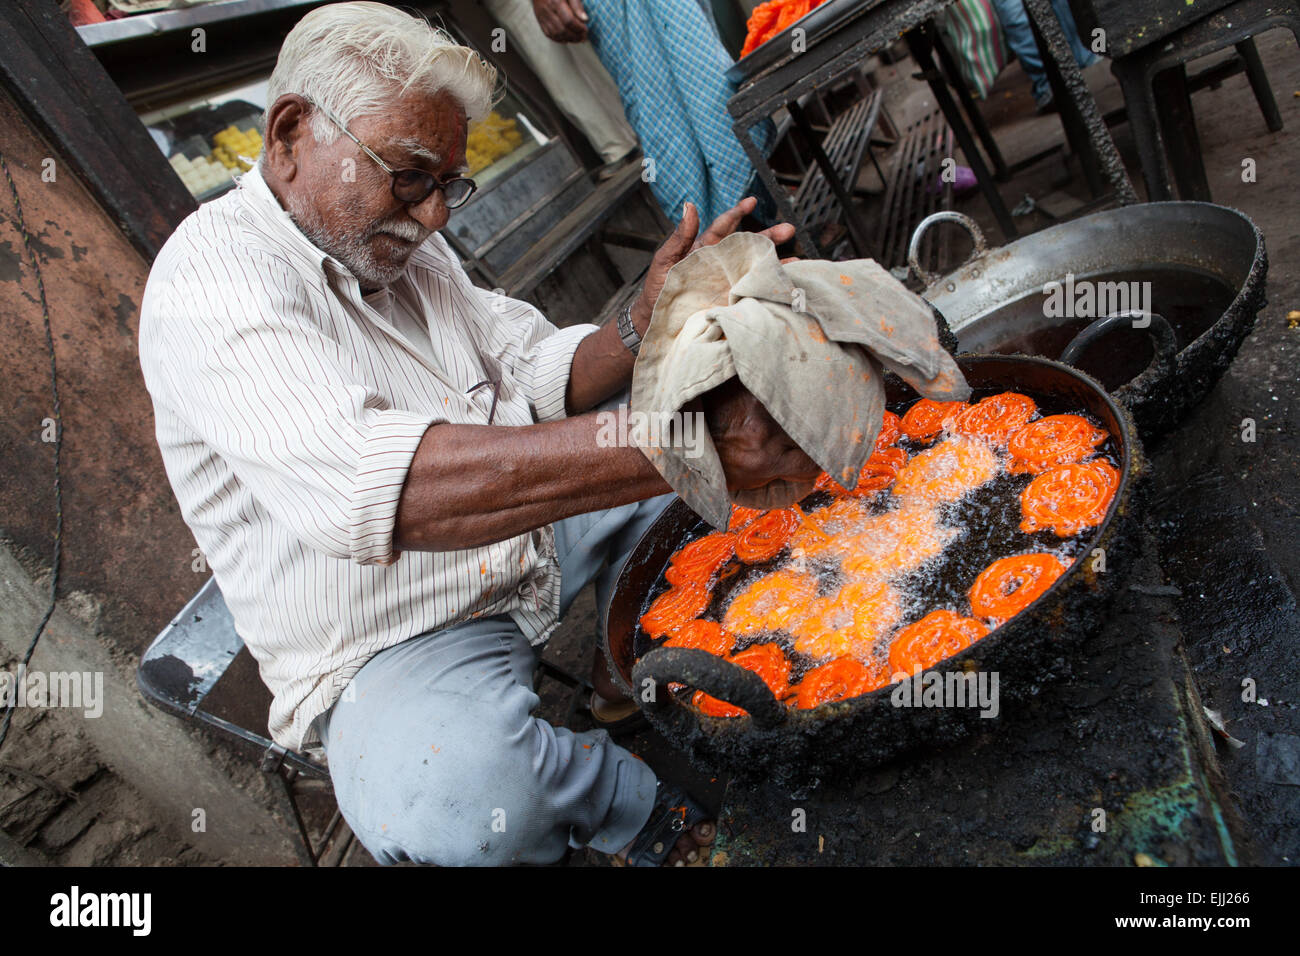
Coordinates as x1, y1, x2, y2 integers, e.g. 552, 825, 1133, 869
77, 0, 595, 289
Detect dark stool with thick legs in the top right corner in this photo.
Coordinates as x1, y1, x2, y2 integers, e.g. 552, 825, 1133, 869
1112, 0, 1300, 202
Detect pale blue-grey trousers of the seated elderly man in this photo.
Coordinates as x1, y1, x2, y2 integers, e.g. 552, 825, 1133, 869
316, 496, 671, 866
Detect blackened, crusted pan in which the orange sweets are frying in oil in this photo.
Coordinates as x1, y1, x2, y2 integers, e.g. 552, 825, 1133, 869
605, 355, 1147, 786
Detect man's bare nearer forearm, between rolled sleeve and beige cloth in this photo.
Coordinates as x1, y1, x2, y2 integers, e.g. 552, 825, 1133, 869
394, 411, 670, 551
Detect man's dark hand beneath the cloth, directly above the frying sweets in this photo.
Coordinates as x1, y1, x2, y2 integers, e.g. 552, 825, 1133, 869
699, 378, 822, 497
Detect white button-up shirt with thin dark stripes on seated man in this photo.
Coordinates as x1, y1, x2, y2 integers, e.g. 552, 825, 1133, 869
140, 169, 595, 749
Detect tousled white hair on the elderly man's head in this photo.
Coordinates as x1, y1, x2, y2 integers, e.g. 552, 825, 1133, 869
267, 3, 497, 146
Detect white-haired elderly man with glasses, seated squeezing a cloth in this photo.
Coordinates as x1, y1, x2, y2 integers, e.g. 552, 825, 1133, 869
140, 3, 818, 865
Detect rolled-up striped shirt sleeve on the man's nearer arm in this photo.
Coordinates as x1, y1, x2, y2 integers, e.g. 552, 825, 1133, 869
140, 255, 441, 564
